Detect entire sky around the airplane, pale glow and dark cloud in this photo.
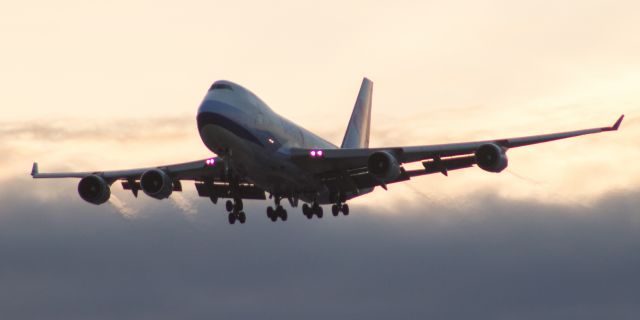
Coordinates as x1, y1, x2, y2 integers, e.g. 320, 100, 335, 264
0, 0, 640, 319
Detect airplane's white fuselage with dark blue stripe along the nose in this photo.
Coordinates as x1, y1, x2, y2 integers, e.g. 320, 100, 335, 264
197, 81, 337, 203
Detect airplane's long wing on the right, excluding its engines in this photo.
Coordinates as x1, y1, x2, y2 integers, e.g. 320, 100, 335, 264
290, 115, 624, 188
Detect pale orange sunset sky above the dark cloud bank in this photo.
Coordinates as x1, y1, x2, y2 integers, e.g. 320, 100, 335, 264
0, 0, 640, 212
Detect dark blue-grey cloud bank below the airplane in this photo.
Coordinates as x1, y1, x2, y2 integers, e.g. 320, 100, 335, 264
0, 183, 640, 320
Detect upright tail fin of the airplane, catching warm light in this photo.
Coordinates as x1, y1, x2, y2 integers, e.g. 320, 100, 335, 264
340, 78, 373, 148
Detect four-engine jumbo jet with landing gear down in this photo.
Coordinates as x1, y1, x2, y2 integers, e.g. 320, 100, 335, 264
31, 78, 624, 224
